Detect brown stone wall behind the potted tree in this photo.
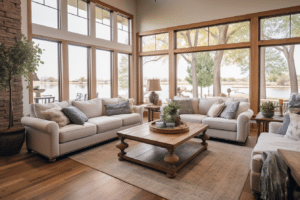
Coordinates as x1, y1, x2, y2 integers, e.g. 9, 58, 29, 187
0, 0, 22, 129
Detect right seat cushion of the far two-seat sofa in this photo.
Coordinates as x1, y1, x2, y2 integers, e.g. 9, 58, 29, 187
202, 117, 237, 132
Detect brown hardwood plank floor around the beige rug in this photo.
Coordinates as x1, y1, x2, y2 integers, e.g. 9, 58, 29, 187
0, 116, 256, 200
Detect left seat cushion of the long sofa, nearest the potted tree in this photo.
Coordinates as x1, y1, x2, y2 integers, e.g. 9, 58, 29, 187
59, 123, 96, 143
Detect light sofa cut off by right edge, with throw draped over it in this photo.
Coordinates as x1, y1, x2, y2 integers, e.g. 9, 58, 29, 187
250, 122, 300, 193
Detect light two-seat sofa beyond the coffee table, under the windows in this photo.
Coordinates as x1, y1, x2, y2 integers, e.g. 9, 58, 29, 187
161, 98, 253, 143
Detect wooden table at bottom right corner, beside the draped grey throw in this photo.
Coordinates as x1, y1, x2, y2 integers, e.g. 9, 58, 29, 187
277, 149, 300, 200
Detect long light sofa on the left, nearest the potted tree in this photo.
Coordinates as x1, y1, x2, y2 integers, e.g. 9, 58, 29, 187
21, 98, 144, 161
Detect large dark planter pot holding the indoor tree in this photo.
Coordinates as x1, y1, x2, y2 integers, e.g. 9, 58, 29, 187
0, 128, 25, 156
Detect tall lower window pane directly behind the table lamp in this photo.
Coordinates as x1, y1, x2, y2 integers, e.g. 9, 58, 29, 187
142, 55, 169, 103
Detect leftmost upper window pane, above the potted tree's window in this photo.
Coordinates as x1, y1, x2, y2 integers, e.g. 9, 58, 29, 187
31, 0, 60, 29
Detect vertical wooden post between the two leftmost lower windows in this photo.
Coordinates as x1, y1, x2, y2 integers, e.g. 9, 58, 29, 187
61, 41, 70, 101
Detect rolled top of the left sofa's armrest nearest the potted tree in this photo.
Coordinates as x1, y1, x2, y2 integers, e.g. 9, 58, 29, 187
21, 117, 59, 134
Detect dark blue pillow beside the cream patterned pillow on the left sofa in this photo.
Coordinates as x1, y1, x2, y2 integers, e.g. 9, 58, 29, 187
61, 106, 89, 125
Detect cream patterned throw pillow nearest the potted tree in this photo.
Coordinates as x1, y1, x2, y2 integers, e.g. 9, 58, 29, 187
42, 108, 70, 127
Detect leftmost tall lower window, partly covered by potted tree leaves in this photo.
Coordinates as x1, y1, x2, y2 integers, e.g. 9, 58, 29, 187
33, 39, 61, 101
